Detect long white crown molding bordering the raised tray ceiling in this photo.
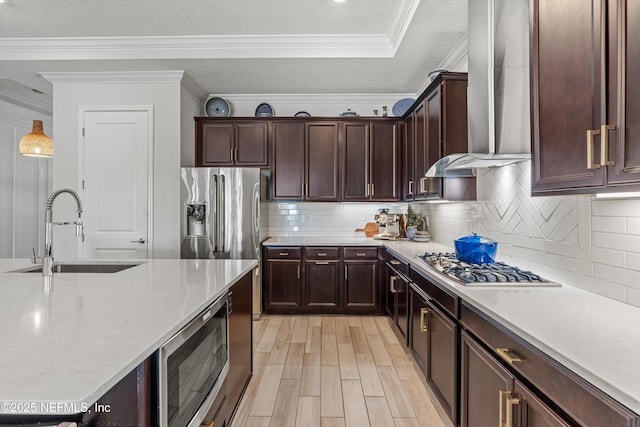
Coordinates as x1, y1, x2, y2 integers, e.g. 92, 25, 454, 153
0, 0, 420, 61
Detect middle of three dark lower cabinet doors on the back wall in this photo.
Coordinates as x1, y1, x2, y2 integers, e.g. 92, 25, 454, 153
304, 260, 340, 313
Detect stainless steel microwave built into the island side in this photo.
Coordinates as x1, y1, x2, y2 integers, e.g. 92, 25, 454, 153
158, 293, 229, 427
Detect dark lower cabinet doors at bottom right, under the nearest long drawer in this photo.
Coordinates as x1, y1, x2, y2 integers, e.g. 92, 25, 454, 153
460, 331, 572, 427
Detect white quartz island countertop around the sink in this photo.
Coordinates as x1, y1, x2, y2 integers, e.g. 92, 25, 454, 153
0, 259, 257, 414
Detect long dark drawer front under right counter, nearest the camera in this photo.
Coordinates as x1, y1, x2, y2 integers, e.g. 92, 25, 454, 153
460, 302, 637, 426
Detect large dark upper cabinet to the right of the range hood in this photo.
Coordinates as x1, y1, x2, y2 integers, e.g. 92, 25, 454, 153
531, 0, 640, 195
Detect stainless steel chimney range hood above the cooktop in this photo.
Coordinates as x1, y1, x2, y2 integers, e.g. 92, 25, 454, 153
425, 0, 531, 177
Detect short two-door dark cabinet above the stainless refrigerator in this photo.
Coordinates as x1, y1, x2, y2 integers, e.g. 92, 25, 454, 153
195, 117, 269, 166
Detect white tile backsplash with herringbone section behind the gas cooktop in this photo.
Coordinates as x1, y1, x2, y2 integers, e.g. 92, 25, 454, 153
412, 162, 640, 306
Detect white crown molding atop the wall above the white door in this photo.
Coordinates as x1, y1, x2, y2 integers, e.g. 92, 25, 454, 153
38, 71, 184, 84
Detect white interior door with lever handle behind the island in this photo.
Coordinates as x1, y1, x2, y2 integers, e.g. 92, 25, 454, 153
82, 110, 151, 259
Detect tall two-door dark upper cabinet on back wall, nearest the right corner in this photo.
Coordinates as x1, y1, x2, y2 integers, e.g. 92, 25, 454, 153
341, 119, 400, 202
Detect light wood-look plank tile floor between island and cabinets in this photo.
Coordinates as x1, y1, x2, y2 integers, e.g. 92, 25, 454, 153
232, 316, 445, 427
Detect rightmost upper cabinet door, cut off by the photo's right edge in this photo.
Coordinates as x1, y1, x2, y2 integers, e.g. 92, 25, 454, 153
607, 1, 640, 185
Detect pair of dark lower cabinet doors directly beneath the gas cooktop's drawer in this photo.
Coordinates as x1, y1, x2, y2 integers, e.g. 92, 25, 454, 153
409, 285, 458, 424
